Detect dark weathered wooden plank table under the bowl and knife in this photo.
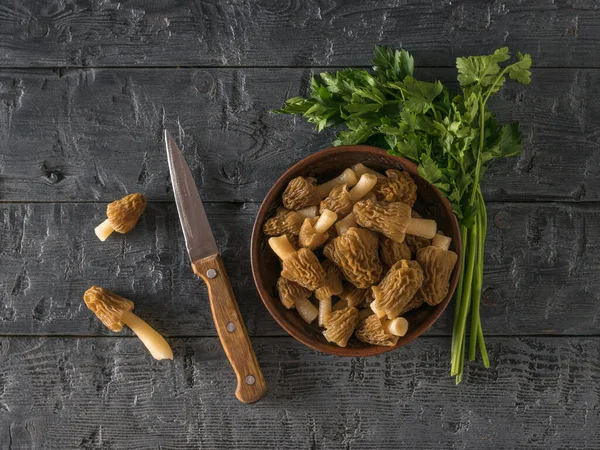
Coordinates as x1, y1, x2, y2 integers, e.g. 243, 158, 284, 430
0, 0, 600, 450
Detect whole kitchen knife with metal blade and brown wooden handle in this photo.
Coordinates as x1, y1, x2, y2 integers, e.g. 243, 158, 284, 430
164, 129, 267, 403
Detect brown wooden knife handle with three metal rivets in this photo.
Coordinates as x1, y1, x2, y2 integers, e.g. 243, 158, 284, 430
192, 255, 267, 403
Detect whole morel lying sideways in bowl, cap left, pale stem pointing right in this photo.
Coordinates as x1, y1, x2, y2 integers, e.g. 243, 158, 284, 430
353, 200, 437, 242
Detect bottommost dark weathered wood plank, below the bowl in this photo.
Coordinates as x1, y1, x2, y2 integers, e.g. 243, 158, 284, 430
0, 338, 600, 450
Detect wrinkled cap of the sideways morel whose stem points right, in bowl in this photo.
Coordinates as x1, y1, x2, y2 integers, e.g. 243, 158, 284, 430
353, 200, 410, 242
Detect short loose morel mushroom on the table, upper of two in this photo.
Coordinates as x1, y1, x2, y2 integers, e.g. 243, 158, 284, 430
94, 193, 146, 241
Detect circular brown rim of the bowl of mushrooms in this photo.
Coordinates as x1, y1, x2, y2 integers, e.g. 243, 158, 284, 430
250, 145, 462, 357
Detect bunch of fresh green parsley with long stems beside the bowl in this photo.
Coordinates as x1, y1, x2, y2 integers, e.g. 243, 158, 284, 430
276, 47, 531, 383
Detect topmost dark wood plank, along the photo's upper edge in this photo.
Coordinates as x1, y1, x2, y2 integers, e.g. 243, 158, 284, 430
0, 0, 600, 67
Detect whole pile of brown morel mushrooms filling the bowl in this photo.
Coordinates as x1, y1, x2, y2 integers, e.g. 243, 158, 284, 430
263, 164, 457, 347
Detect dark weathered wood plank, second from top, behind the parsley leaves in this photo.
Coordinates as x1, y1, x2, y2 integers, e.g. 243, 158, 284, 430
0, 69, 600, 202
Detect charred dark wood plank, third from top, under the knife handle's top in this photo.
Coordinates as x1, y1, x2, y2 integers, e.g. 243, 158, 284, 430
0, 203, 600, 336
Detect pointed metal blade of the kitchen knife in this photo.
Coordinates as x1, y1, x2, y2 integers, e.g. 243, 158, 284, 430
164, 129, 219, 262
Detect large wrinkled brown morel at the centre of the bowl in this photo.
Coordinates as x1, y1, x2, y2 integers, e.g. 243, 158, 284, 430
323, 228, 383, 289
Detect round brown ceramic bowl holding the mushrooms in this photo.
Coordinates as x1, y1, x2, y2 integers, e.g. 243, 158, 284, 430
251, 145, 461, 356
